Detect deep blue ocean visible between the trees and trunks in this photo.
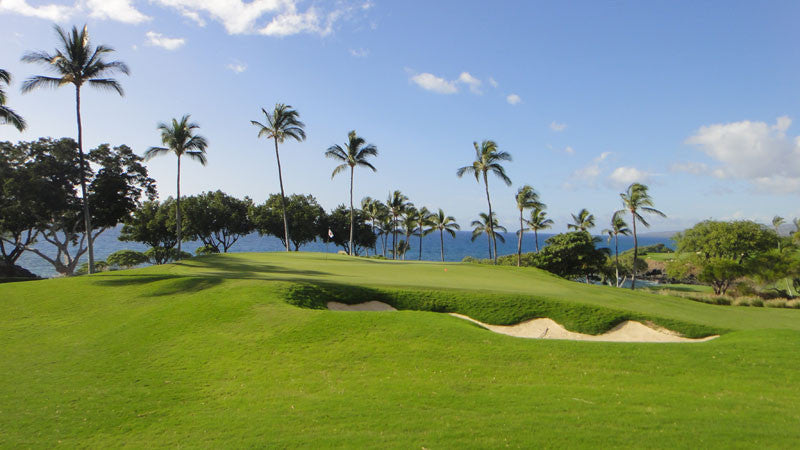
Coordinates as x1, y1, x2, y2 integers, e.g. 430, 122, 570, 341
17, 227, 675, 277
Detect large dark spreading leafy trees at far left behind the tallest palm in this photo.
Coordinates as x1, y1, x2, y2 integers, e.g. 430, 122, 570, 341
3, 139, 155, 275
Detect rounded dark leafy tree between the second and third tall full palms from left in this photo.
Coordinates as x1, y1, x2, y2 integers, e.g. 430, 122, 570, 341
182, 191, 255, 253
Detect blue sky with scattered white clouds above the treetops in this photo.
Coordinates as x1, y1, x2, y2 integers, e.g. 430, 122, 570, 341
0, 0, 800, 231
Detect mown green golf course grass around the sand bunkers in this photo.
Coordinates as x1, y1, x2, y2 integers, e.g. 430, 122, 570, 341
0, 253, 800, 448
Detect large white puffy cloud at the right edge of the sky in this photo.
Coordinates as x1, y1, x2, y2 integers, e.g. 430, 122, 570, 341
686, 117, 800, 193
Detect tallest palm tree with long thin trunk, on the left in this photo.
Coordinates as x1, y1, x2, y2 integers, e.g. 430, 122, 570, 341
22, 25, 130, 273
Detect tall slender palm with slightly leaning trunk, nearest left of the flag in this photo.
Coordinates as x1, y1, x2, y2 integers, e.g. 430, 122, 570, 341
250, 103, 306, 252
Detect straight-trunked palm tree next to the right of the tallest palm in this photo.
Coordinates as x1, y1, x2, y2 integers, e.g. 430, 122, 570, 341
144, 114, 208, 259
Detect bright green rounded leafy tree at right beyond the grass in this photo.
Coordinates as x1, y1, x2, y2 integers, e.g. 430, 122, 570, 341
667, 220, 777, 294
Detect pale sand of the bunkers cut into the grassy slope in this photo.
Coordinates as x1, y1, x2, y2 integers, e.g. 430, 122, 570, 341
328, 300, 719, 342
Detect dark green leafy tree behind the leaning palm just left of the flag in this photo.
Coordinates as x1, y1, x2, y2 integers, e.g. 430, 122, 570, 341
249, 194, 328, 251
